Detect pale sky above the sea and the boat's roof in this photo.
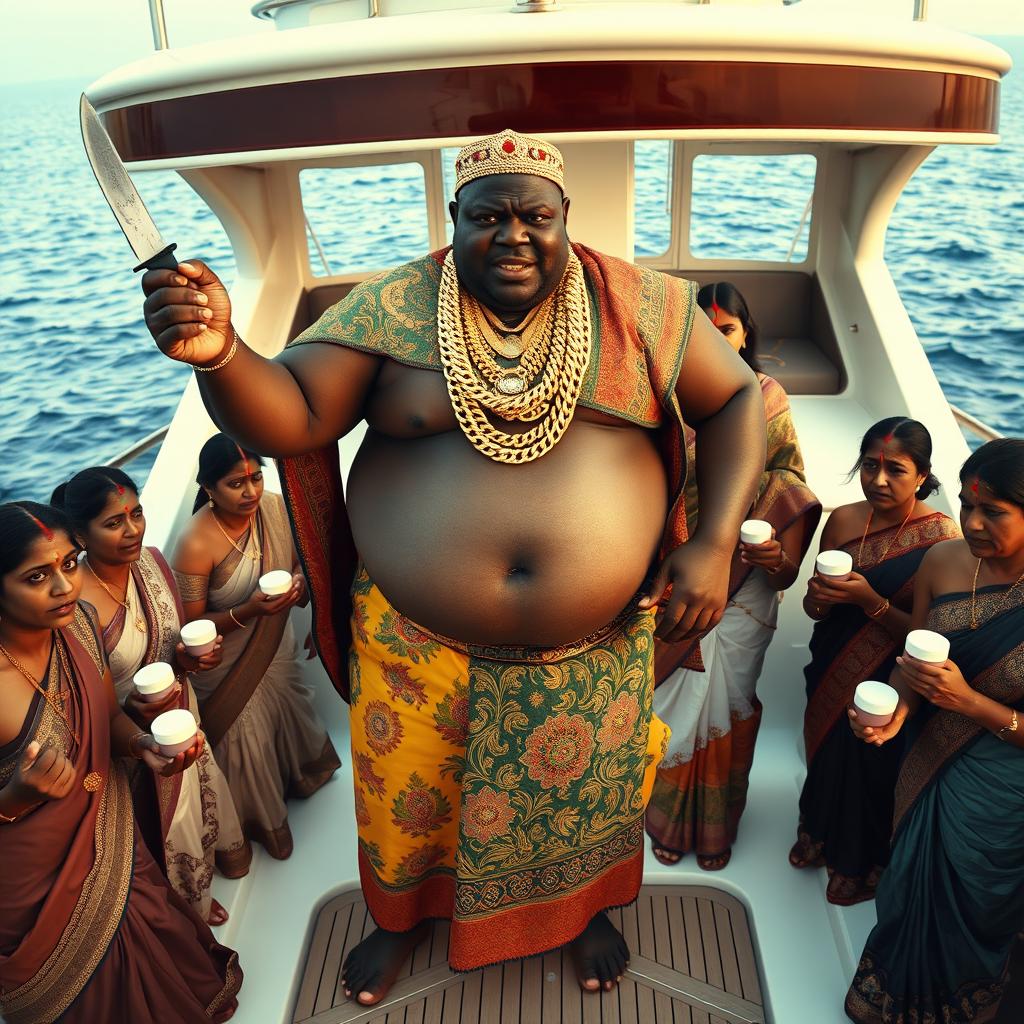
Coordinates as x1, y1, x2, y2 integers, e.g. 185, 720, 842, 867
0, 0, 1024, 84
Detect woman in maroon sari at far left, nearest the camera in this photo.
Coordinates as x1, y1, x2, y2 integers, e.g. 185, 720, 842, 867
0, 502, 242, 1024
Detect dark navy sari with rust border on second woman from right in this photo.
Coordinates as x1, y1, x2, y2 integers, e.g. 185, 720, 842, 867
799, 512, 959, 889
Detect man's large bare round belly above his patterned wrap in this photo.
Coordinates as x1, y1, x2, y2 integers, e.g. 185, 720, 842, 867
347, 420, 668, 647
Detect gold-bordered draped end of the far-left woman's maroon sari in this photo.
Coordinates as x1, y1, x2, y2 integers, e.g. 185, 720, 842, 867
0, 605, 134, 1024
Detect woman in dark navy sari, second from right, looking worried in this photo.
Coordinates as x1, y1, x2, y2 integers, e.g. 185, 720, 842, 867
790, 416, 959, 906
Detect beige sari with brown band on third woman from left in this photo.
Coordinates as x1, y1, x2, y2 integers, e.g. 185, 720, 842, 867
177, 494, 341, 859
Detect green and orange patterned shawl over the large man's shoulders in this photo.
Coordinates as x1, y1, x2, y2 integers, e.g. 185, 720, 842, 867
279, 245, 696, 700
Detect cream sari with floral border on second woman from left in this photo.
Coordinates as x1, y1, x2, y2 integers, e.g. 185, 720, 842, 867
103, 548, 252, 921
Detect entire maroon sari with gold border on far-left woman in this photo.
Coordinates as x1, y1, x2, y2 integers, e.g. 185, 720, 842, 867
0, 606, 242, 1024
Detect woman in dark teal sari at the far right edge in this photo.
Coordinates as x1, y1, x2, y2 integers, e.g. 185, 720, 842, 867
846, 438, 1024, 1024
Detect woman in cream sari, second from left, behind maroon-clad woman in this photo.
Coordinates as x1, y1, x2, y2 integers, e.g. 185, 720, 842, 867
52, 467, 252, 925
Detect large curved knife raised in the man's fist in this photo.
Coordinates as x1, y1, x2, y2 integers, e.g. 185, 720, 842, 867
79, 92, 178, 272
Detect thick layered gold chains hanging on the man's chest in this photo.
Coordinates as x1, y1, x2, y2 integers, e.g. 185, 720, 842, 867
437, 251, 591, 465
